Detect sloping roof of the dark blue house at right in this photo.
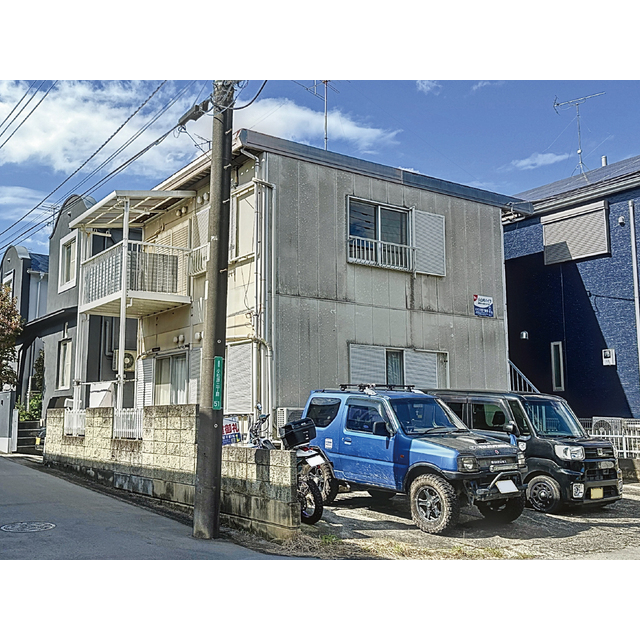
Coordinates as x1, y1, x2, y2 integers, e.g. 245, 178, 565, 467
516, 156, 640, 212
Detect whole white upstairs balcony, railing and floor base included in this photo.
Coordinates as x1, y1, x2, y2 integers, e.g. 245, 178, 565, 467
79, 241, 192, 318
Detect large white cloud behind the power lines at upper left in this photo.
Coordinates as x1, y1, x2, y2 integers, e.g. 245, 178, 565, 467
0, 81, 202, 177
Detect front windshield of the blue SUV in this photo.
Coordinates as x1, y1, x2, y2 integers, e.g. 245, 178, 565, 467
389, 398, 468, 438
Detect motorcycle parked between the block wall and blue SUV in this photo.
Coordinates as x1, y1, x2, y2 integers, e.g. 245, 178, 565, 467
249, 405, 324, 524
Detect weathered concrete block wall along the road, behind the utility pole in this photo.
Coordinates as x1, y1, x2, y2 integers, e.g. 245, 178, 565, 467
44, 405, 300, 539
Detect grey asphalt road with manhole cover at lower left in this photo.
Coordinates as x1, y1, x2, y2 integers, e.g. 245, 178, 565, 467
0, 455, 278, 560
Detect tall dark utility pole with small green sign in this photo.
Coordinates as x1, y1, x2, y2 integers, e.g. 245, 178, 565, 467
193, 80, 237, 539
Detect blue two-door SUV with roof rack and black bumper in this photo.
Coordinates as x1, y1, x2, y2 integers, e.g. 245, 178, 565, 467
303, 385, 526, 534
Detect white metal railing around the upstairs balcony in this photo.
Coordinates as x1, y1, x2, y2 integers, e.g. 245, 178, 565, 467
82, 241, 192, 305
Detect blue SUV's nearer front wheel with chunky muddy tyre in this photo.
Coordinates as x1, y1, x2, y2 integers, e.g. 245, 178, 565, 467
409, 474, 460, 534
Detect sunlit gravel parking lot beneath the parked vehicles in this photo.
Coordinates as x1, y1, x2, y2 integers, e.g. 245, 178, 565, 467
258, 484, 640, 559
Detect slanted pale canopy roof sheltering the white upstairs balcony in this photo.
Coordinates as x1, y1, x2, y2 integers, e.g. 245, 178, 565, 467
69, 190, 196, 229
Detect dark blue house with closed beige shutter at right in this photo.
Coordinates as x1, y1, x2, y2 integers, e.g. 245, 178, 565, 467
503, 156, 640, 418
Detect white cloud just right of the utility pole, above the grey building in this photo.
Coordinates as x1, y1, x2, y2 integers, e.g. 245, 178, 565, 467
233, 98, 399, 153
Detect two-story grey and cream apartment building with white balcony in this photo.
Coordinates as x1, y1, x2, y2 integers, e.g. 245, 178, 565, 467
50, 130, 530, 450
